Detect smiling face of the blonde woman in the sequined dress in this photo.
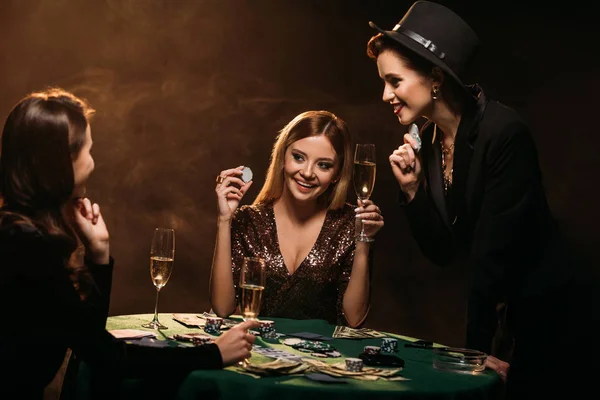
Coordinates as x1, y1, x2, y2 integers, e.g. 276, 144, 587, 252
283, 135, 339, 201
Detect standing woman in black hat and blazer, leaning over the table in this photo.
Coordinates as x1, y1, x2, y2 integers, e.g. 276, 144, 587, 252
367, 1, 586, 396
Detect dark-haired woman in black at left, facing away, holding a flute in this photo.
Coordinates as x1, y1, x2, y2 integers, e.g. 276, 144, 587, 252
0, 89, 258, 399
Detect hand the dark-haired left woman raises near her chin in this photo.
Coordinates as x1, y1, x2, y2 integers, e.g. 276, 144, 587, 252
65, 198, 110, 264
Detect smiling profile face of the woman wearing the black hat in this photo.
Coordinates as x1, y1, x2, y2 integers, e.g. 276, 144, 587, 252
377, 49, 440, 125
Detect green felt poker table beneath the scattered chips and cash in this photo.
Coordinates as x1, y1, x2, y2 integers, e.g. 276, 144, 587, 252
78, 313, 503, 400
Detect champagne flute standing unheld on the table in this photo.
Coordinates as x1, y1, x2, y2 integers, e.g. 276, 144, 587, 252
142, 228, 175, 329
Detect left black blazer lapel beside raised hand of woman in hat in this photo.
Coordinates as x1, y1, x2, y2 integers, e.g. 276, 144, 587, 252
423, 123, 452, 229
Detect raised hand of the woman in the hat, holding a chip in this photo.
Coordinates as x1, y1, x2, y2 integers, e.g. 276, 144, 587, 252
389, 133, 421, 202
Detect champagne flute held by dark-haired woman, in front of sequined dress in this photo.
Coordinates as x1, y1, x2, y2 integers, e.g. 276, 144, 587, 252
240, 257, 266, 321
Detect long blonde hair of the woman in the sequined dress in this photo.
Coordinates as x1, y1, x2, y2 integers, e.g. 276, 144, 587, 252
253, 111, 352, 209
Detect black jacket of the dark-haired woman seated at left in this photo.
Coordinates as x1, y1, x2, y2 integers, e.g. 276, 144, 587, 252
0, 217, 223, 399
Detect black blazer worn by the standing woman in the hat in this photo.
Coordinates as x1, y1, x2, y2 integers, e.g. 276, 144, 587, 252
405, 86, 572, 353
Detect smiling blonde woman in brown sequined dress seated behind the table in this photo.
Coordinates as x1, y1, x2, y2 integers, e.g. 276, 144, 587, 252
210, 111, 383, 326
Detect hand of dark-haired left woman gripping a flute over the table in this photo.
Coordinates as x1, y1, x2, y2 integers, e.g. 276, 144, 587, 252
215, 320, 260, 367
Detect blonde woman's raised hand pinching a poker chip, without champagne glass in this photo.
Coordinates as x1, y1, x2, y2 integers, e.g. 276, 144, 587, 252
215, 166, 252, 221
